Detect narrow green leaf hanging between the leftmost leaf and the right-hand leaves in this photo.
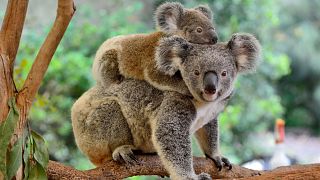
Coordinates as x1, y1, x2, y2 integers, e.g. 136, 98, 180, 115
7, 137, 23, 179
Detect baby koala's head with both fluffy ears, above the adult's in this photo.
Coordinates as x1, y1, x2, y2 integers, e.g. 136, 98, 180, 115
155, 2, 218, 44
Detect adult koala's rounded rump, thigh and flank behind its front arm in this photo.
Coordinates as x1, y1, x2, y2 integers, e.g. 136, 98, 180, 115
71, 80, 163, 161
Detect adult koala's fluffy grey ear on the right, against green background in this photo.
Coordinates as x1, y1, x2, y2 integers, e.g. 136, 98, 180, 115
227, 33, 261, 72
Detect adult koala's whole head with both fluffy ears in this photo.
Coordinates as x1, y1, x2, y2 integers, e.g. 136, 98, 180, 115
156, 34, 260, 102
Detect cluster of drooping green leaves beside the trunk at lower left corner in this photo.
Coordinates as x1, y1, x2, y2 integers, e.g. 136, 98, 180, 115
0, 98, 49, 179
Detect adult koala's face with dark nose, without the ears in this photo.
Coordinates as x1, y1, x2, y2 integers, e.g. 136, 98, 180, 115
179, 44, 237, 101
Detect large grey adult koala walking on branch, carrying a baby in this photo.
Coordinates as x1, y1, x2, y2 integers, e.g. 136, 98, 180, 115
71, 34, 260, 179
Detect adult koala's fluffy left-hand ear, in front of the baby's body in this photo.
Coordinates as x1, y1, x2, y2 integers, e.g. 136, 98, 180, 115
155, 36, 193, 76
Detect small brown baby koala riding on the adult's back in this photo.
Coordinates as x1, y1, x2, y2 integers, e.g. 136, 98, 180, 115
92, 2, 218, 95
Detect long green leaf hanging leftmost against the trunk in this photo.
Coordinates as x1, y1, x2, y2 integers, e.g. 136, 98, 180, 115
0, 98, 19, 178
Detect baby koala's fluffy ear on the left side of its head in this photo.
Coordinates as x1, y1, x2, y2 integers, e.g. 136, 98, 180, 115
155, 2, 184, 33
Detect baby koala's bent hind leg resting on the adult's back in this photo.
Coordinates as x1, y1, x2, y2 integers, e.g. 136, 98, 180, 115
93, 49, 123, 87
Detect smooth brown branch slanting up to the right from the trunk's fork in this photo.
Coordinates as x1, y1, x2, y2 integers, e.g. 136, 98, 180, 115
17, 0, 76, 112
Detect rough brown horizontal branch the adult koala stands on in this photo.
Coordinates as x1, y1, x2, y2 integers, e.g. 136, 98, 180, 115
47, 155, 320, 179
